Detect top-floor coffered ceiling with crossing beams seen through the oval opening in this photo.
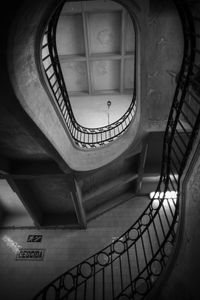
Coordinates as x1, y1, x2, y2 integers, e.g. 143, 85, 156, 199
56, 1, 135, 96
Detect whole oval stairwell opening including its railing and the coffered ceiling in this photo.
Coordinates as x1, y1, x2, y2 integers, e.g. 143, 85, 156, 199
41, 1, 138, 149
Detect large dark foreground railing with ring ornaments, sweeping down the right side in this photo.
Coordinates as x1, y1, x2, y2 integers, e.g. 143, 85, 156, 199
34, 0, 200, 300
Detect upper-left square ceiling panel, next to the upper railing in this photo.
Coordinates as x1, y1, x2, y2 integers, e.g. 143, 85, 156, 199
56, 14, 85, 55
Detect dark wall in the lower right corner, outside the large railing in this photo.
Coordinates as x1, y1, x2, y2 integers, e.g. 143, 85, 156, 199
159, 141, 200, 300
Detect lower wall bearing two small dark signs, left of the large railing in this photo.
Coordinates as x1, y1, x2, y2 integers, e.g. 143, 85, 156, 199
0, 197, 149, 300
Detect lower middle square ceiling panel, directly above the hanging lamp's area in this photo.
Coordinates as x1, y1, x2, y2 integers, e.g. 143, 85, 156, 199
91, 60, 120, 92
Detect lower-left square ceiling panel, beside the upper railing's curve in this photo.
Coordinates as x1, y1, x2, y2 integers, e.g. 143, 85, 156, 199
62, 61, 88, 92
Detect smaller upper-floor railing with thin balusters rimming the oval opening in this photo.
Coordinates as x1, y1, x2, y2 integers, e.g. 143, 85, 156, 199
41, 3, 136, 148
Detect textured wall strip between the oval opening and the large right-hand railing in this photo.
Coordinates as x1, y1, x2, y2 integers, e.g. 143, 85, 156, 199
146, 0, 183, 130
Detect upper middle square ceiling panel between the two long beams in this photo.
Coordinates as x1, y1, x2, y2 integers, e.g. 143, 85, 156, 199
87, 12, 121, 54
